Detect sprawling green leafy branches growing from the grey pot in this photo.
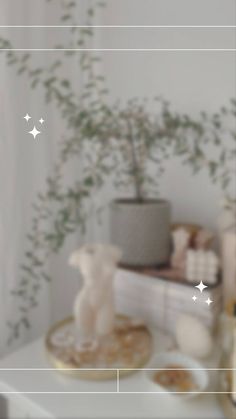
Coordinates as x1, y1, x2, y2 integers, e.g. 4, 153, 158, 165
0, 0, 236, 340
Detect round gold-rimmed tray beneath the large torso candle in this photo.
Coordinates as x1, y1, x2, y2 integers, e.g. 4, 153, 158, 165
45, 316, 152, 380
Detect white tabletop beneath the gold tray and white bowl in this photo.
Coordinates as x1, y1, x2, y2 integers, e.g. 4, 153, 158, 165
0, 333, 224, 419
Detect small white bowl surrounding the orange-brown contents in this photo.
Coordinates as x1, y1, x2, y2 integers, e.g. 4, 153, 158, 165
144, 351, 209, 399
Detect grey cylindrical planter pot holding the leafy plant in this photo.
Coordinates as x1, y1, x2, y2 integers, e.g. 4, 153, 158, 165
110, 200, 170, 266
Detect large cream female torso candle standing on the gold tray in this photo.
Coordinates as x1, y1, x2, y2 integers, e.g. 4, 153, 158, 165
69, 244, 121, 350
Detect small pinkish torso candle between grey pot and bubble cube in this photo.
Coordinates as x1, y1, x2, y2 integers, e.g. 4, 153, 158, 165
171, 228, 190, 271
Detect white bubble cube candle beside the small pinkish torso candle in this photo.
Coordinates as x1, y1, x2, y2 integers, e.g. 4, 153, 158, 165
185, 250, 219, 284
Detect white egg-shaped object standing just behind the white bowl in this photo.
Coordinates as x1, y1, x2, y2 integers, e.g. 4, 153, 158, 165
175, 315, 213, 358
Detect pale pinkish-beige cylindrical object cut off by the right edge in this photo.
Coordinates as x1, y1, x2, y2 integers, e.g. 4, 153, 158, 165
222, 229, 236, 304
